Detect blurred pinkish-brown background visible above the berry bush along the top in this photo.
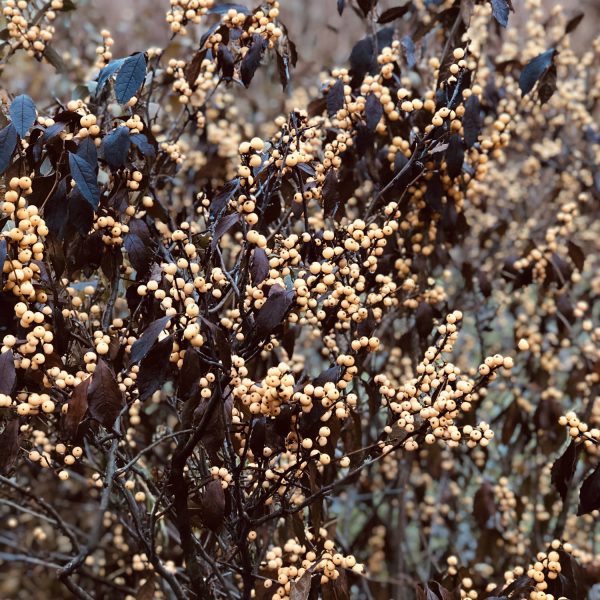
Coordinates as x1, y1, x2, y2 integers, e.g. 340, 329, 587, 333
0, 0, 600, 108
